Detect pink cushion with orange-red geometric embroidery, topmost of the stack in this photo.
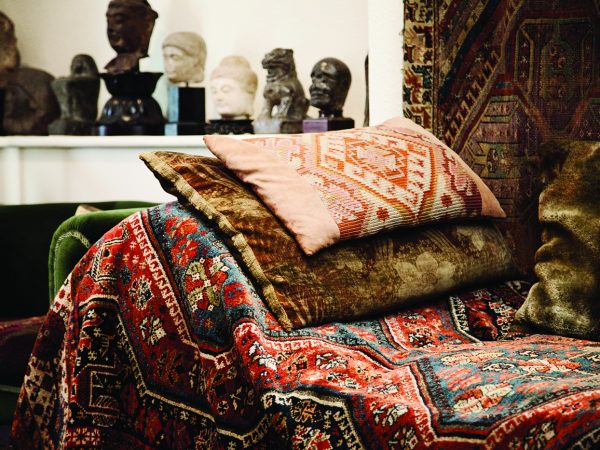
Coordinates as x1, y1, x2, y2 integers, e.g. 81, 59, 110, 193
204, 117, 505, 255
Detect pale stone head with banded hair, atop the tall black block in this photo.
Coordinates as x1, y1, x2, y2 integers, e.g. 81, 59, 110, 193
162, 31, 206, 87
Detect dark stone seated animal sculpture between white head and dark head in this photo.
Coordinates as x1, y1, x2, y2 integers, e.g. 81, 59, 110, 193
254, 48, 308, 133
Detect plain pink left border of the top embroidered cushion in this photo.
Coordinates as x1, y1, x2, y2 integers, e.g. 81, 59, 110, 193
204, 135, 340, 255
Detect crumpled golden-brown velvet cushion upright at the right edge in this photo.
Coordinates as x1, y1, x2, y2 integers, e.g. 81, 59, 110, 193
515, 141, 600, 341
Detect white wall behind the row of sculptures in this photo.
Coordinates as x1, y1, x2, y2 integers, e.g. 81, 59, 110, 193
0, 0, 368, 125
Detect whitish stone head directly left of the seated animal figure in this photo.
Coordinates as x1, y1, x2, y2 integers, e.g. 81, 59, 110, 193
210, 55, 258, 119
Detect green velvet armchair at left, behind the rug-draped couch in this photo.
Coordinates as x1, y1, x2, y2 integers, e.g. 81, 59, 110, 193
0, 201, 152, 425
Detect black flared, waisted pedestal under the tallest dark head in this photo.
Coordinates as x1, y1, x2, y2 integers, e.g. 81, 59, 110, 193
94, 72, 165, 136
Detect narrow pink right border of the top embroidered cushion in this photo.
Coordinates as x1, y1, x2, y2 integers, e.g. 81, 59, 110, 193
381, 116, 506, 219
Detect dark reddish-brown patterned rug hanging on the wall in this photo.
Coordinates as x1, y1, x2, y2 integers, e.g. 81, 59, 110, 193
404, 0, 600, 270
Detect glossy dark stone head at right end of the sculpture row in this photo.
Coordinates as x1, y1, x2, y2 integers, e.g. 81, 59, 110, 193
309, 58, 352, 118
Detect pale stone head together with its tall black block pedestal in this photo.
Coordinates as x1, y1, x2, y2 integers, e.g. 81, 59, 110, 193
162, 31, 206, 135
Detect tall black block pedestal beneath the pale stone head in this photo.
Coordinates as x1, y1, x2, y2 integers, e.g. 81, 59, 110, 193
165, 86, 206, 136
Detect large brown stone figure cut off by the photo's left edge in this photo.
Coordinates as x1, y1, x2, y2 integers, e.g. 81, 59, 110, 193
0, 12, 60, 135
